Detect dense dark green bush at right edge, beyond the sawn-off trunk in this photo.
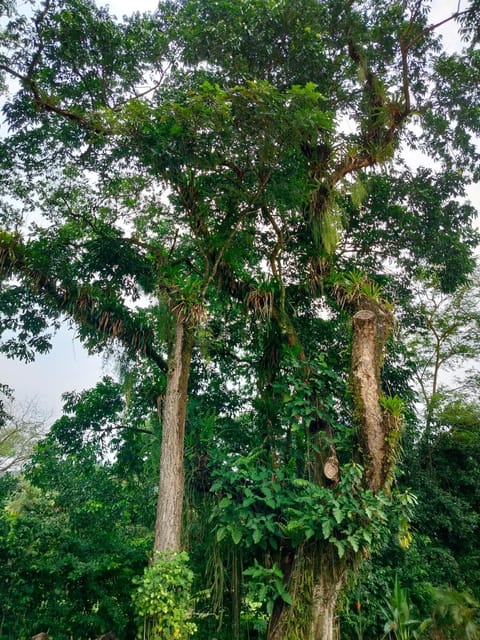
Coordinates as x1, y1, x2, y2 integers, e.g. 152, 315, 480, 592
410, 398, 480, 595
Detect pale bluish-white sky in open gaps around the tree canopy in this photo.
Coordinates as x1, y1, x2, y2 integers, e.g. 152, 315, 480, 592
0, 0, 480, 422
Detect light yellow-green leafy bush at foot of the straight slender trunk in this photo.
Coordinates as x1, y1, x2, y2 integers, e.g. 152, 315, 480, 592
134, 552, 196, 640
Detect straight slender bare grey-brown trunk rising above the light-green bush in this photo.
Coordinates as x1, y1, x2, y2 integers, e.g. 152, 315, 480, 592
153, 310, 194, 552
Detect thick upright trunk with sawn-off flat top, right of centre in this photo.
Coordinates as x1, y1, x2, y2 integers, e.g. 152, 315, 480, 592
352, 309, 392, 491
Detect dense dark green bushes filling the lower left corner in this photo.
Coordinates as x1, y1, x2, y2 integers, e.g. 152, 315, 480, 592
2, 473, 150, 640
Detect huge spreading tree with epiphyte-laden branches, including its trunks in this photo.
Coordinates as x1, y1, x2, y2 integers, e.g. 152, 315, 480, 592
0, 0, 479, 640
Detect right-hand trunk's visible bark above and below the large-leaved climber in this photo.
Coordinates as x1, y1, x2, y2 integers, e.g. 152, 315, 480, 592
267, 303, 397, 640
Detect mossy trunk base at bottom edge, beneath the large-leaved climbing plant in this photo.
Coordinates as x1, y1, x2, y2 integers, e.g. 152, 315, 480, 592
267, 544, 348, 640
